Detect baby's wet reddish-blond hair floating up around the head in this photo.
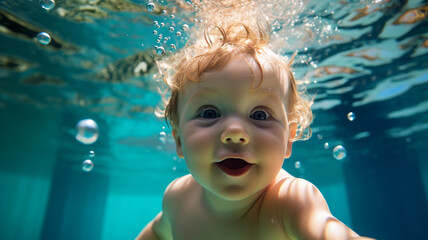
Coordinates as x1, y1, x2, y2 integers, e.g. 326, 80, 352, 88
157, 22, 312, 140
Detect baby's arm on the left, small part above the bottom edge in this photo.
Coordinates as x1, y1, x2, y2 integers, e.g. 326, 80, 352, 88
136, 212, 172, 240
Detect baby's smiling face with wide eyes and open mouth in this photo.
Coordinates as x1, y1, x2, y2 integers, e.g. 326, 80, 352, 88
173, 57, 293, 200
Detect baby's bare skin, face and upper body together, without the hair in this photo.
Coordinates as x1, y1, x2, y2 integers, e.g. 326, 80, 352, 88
137, 56, 372, 240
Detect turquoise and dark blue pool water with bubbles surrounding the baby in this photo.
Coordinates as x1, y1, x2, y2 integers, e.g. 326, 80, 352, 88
0, 0, 428, 240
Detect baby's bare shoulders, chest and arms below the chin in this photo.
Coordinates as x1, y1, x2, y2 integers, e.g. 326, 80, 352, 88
137, 170, 369, 240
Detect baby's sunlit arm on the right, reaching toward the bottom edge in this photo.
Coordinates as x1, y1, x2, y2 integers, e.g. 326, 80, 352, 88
280, 178, 370, 240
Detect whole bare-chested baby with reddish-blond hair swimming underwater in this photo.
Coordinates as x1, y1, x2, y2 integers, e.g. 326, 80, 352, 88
137, 15, 372, 240
